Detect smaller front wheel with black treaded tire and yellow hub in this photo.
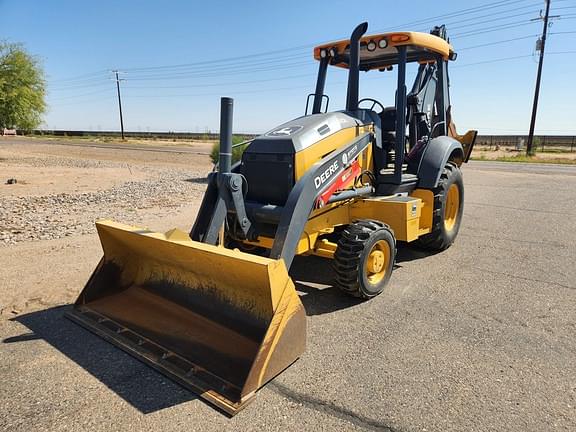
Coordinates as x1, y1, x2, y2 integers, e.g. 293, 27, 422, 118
334, 220, 396, 299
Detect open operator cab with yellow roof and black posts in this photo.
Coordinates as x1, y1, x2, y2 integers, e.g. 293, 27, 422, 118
312, 23, 456, 193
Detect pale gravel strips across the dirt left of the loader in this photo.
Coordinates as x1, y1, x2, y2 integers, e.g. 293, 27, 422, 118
0, 157, 206, 245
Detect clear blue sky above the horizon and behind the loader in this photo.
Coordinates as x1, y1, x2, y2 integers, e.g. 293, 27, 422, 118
0, 0, 576, 134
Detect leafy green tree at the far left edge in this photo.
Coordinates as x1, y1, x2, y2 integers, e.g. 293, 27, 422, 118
0, 41, 46, 130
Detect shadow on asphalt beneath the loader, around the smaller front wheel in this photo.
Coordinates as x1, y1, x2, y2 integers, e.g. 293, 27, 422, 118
290, 243, 432, 316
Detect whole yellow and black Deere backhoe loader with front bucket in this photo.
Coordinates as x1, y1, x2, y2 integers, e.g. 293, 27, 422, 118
68, 23, 476, 415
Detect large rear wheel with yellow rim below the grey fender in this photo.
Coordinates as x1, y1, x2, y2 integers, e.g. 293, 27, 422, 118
416, 162, 464, 251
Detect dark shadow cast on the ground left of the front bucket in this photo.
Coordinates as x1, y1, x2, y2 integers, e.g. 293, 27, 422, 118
2, 306, 198, 414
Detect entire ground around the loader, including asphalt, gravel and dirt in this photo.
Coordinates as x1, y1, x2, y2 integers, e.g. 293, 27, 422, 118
0, 139, 576, 432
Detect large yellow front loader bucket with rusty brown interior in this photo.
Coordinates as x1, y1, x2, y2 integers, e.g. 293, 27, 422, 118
67, 221, 306, 415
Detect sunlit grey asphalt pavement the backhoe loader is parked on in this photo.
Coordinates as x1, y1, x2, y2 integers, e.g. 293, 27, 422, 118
0, 162, 576, 431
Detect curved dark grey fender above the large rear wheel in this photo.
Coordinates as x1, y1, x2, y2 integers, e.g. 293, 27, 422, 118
418, 136, 464, 189
